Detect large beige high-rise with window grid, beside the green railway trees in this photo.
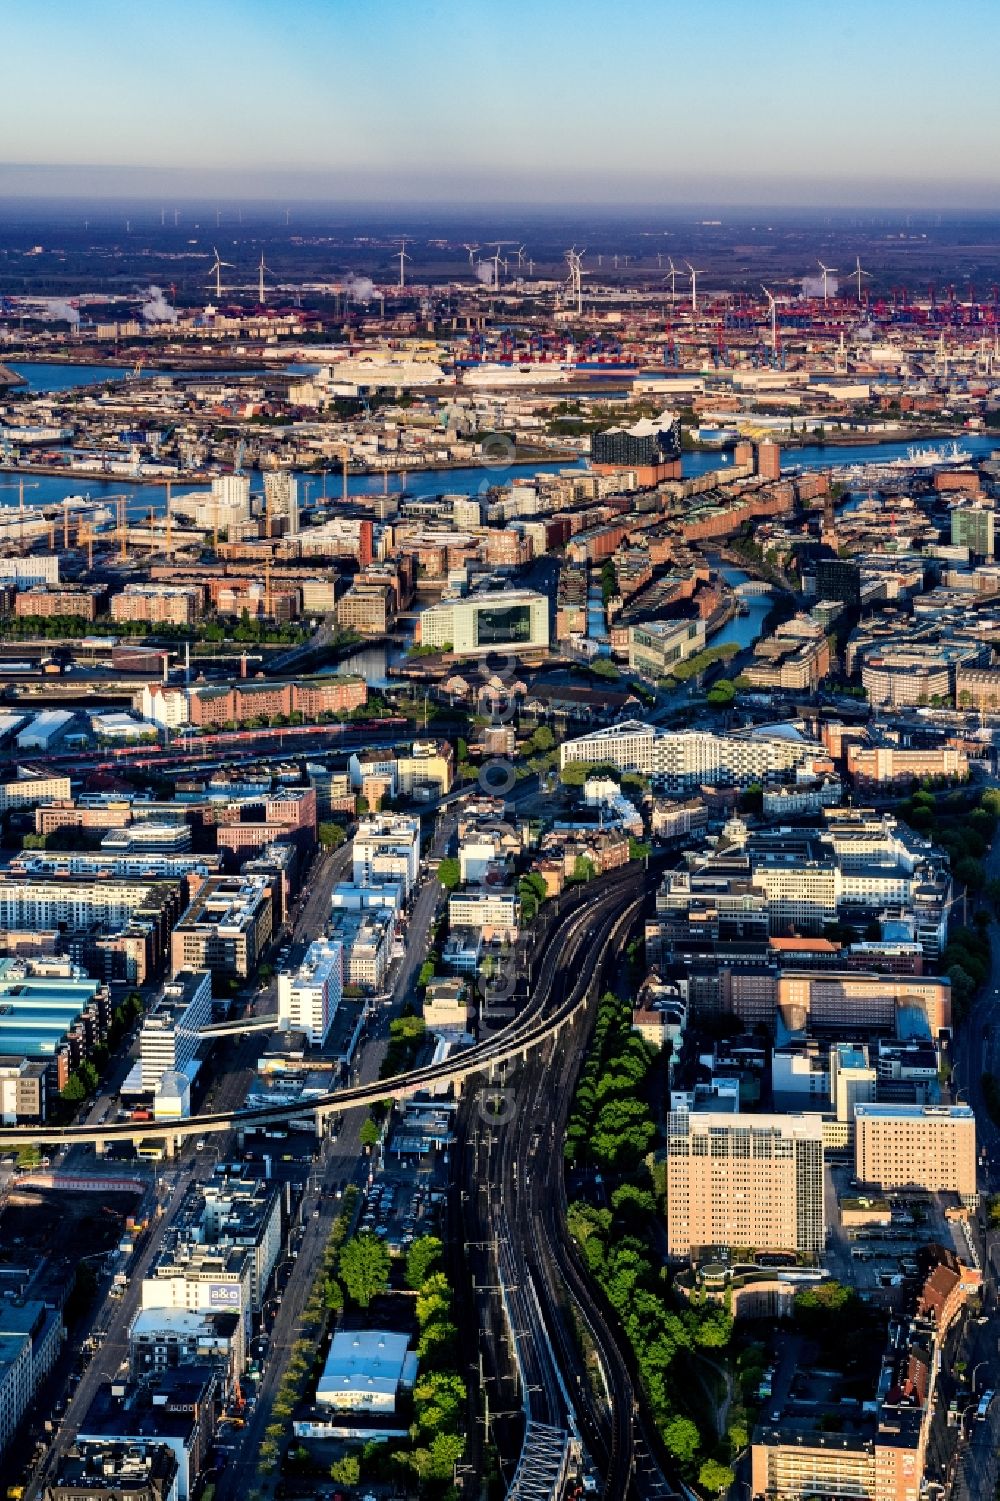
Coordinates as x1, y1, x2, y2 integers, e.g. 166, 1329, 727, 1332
667, 1111, 824, 1259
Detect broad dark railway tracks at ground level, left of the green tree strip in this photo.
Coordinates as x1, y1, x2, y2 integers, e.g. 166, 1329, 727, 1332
462, 883, 657, 1501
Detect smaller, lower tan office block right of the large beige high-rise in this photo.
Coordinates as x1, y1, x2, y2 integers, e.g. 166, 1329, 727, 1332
854, 1105, 976, 1202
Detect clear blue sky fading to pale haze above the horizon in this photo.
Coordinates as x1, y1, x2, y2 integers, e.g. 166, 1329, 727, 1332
0, 0, 1000, 209
